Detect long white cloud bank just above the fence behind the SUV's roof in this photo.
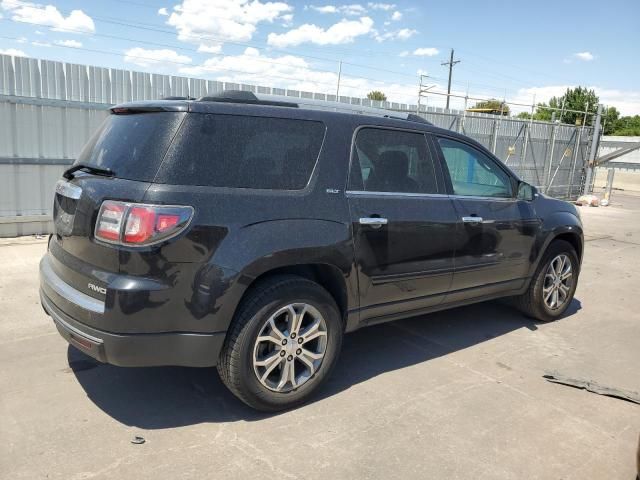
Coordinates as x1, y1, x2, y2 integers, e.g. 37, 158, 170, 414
180, 47, 417, 103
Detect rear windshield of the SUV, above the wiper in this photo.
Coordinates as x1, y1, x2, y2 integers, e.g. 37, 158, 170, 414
75, 112, 186, 182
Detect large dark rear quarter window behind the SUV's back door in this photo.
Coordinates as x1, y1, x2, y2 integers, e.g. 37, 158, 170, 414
155, 114, 325, 190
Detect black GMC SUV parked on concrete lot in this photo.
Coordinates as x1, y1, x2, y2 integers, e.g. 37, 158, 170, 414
40, 92, 583, 411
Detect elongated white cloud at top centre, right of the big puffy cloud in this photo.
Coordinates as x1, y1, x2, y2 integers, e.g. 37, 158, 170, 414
267, 17, 373, 48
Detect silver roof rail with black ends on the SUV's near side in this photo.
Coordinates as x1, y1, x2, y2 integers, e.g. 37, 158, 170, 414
197, 90, 433, 125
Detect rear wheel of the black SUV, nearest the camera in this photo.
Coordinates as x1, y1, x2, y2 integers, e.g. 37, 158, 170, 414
218, 275, 343, 412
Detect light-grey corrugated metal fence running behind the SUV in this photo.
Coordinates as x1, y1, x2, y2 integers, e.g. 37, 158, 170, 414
0, 55, 591, 237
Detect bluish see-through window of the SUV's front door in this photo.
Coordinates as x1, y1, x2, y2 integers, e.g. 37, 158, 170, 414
438, 138, 512, 198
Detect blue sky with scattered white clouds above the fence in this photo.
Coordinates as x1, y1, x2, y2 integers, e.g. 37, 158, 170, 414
0, 0, 640, 115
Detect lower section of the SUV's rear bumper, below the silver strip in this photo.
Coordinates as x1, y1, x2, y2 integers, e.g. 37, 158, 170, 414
40, 279, 225, 367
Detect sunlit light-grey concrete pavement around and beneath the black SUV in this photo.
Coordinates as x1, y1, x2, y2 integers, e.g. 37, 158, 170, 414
0, 193, 640, 480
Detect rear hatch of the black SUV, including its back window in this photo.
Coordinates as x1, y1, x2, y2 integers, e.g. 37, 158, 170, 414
48, 106, 186, 312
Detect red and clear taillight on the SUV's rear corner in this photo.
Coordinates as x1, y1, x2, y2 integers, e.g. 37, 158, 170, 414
95, 200, 193, 246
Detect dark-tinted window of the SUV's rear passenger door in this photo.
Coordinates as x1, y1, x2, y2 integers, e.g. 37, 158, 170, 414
349, 128, 438, 193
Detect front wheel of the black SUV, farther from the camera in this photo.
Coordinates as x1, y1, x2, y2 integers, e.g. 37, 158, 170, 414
513, 240, 580, 322
